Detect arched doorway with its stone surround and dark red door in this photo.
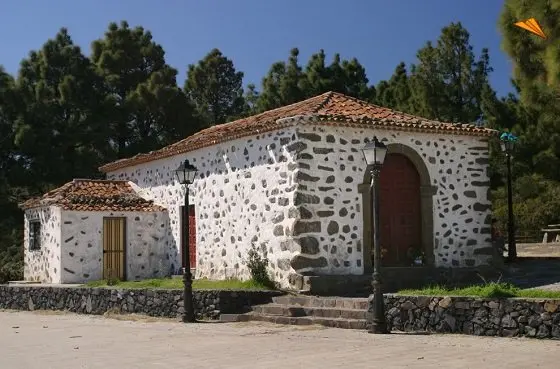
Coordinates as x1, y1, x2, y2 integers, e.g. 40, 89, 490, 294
358, 143, 437, 274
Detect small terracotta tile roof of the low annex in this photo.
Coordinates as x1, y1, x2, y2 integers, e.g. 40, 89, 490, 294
20, 179, 165, 211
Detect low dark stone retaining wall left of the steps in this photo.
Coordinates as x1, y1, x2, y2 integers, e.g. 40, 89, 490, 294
0, 285, 282, 319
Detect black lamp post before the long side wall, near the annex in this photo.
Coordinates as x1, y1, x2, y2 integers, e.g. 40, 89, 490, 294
174, 159, 197, 323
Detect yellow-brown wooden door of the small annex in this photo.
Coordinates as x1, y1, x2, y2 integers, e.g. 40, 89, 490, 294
103, 218, 126, 281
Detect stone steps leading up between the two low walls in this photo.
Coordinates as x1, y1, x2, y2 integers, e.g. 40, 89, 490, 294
221, 295, 368, 329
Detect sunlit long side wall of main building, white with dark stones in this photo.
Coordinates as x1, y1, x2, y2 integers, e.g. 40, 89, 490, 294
107, 128, 299, 287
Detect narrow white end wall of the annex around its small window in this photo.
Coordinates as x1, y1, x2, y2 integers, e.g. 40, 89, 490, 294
23, 206, 61, 283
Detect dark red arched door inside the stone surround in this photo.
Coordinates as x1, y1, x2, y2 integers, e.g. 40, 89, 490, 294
379, 154, 422, 266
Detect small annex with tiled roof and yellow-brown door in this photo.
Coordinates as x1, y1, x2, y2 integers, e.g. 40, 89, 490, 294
20, 179, 172, 283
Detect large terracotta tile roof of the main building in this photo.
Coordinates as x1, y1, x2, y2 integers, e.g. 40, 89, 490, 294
99, 92, 496, 172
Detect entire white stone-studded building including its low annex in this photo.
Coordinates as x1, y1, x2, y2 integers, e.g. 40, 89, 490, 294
19, 92, 496, 289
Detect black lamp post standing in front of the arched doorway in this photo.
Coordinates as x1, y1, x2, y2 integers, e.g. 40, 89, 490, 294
362, 136, 388, 334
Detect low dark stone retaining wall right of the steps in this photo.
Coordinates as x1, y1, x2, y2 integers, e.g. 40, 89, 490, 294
368, 295, 560, 339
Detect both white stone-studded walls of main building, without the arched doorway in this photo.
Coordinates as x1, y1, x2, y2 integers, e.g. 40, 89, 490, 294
107, 118, 490, 286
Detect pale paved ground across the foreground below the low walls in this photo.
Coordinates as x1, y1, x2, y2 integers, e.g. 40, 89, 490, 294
0, 311, 560, 369
